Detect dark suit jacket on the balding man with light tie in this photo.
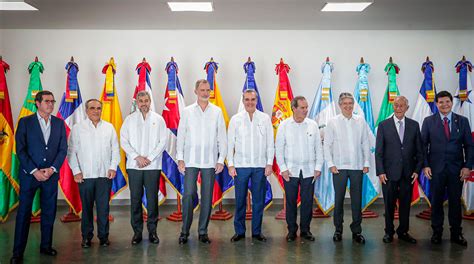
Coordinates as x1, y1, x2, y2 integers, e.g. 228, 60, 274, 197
375, 117, 423, 181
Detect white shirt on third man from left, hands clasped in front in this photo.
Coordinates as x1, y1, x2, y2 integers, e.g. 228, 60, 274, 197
120, 111, 168, 170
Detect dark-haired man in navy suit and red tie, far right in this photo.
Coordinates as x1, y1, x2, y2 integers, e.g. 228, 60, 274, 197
421, 91, 473, 246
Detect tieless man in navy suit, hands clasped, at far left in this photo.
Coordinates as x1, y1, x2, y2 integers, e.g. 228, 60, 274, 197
11, 91, 67, 263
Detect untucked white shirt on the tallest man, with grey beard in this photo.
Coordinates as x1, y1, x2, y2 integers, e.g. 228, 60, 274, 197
176, 102, 227, 168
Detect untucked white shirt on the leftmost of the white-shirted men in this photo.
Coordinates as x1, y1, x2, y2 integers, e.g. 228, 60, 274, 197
67, 119, 120, 179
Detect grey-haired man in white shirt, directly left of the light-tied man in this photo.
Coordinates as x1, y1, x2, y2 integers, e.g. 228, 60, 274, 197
324, 92, 370, 244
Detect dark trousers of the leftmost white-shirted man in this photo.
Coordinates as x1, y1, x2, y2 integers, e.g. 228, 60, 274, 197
79, 177, 112, 240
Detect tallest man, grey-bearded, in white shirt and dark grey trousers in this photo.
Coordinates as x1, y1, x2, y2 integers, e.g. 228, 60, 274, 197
176, 80, 227, 244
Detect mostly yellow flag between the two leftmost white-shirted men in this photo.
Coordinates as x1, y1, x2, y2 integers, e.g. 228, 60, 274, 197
100, 58, 128, 199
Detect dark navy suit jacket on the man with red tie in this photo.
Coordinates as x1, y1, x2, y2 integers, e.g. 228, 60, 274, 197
421, 113, 473, 173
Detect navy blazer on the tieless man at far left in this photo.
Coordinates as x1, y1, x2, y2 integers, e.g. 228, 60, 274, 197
15, 113, 67, 175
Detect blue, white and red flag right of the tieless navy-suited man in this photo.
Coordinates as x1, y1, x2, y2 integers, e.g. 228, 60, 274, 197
56, 61, 86, 215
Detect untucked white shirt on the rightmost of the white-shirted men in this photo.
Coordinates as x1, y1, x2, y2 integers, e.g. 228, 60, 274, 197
323, 114, 370, 170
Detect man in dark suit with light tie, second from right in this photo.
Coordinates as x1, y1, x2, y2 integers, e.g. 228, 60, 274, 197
375, 96, 423, 244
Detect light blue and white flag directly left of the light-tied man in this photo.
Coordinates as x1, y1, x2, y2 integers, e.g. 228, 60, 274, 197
354, 63, 382, 211
